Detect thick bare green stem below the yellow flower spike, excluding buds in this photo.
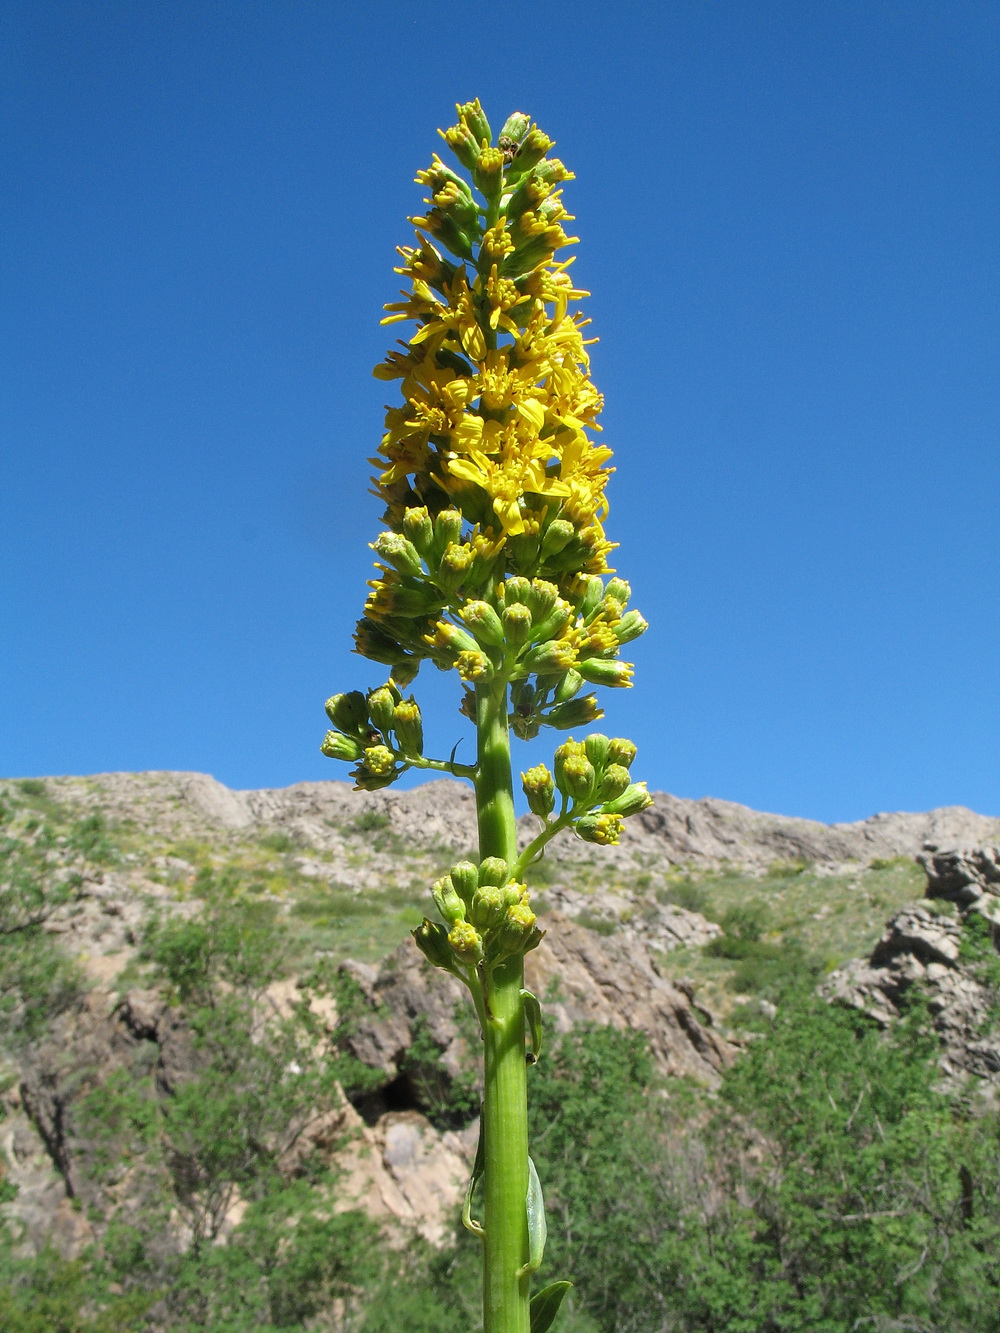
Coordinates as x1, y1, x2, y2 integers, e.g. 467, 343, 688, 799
476, 680, 531, 1333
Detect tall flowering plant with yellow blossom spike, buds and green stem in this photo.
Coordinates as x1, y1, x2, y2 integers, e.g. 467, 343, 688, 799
323, 100, 651, 1333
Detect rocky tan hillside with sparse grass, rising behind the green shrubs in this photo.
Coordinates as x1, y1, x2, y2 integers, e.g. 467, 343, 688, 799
0, 773, 1000, 1256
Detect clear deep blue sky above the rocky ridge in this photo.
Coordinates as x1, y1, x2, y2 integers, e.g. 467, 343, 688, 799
0, 0, 1000, 820
